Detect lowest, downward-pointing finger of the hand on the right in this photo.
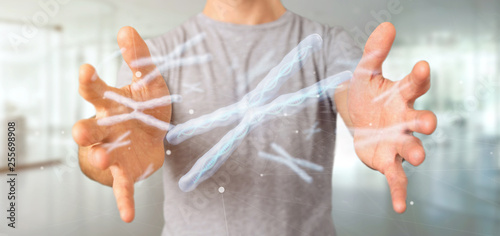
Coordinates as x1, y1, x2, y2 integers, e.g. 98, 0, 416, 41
384, 160, 408, 213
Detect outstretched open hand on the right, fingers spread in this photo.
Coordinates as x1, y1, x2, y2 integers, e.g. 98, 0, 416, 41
347, 23, 437, 213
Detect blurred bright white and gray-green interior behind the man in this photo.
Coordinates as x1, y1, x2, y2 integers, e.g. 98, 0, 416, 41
0, 0, 500, 236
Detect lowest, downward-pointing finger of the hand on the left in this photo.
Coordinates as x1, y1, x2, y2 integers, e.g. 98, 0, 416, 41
109, 165, 135, 223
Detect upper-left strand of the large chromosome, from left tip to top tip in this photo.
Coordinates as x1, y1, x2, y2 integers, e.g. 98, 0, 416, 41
166, 34, 323, 145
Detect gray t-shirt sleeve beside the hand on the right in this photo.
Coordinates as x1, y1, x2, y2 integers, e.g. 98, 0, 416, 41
325, 27, 363, 76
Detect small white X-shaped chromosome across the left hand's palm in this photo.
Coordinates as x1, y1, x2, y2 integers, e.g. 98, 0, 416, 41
97, 91, 181, 131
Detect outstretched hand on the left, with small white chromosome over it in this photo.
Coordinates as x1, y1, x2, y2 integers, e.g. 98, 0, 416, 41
73, 27, 171, 222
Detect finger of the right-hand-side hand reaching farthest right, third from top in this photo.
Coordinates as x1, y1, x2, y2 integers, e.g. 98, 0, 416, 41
405, 110, 437, 135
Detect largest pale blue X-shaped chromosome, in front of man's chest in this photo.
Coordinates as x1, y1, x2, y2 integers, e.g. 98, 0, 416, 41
167, 34, 352, 191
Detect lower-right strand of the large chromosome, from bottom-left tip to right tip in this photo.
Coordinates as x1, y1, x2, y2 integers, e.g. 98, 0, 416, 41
179, 71, 352, 192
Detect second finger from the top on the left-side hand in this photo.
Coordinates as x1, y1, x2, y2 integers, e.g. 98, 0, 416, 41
78, 64, 108, 107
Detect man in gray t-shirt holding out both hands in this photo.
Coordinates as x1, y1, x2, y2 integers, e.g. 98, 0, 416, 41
73, 0, 436, 235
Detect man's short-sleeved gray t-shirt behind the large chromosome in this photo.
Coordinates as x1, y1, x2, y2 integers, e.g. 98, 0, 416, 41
118, 11, 361, 235
